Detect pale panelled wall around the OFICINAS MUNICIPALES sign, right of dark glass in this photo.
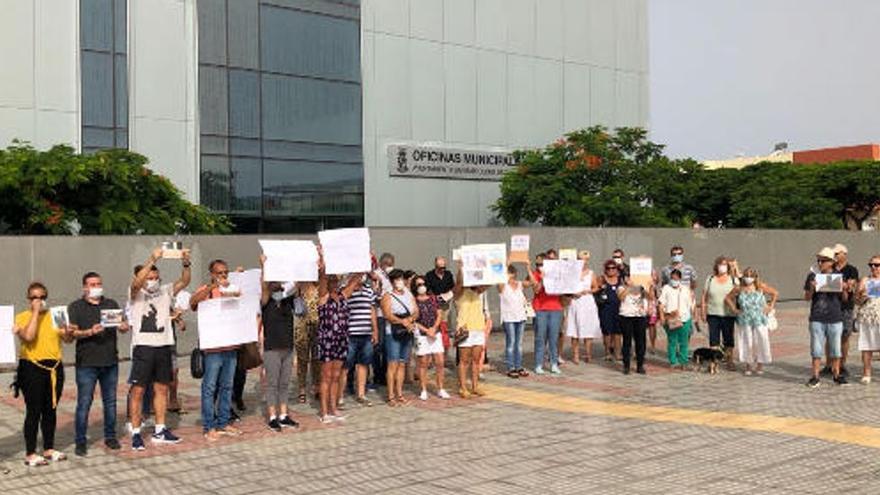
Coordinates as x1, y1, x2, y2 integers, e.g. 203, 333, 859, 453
361, 0, 648, 226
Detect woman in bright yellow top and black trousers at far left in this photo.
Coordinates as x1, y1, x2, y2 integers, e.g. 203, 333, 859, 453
12, 282, 73, 467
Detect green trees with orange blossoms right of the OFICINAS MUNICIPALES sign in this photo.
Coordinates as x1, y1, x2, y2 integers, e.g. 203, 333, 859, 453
493, 126, 880, 229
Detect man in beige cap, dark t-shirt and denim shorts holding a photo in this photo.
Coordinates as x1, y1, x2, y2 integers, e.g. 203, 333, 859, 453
804, 247, 849, 388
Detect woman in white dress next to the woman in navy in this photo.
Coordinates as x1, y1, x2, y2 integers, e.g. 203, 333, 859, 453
565, 251, 602, 364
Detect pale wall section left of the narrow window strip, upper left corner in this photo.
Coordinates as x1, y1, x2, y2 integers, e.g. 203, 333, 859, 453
0, 0, 80, 148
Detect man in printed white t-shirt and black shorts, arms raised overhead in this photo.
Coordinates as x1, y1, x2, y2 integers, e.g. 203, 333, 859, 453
128, 248, 192, 450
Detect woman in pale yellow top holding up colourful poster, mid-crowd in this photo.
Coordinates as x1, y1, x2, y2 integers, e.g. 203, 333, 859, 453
453, 263, 491, 399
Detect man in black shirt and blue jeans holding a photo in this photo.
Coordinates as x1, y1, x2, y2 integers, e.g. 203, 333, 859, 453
67, 272, 128, 456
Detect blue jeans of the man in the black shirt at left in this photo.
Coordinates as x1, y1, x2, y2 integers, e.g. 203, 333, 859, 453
74, 364, 119, 445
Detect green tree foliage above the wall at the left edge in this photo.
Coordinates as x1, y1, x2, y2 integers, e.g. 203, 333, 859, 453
0, 142, 231, 235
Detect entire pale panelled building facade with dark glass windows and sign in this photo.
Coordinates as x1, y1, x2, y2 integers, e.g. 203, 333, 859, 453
0, 0, 649, 232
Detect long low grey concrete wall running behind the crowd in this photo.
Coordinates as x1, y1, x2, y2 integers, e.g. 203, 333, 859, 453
0, 228, 880, 364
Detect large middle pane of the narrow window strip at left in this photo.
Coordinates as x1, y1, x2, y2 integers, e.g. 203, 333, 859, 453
82, 52, 113, 127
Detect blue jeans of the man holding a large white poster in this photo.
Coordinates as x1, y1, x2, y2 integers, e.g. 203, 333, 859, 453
202, 351, 238, 433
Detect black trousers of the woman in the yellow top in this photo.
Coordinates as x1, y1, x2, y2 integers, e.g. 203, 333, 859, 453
16, 359, 64, 455
